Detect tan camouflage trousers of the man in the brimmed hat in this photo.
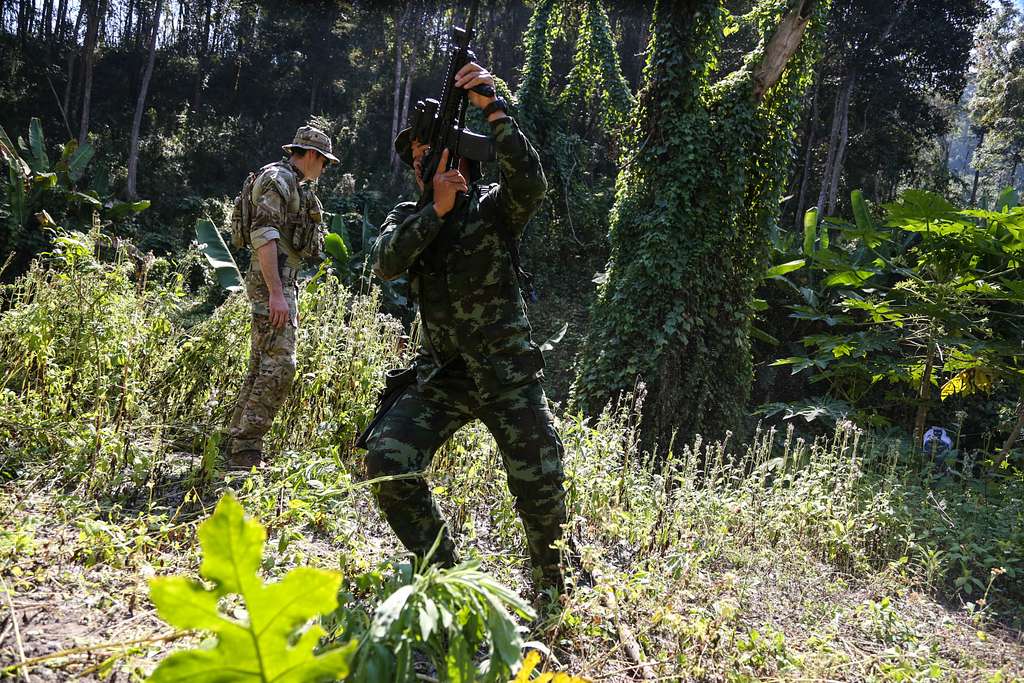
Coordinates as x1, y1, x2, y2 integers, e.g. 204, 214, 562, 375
228, 267, 298, 453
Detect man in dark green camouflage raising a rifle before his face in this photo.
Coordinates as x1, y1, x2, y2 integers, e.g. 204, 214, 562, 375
367, 63, 565, 586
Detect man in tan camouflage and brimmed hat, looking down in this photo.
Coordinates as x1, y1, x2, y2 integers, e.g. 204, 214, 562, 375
229, 126, 338, 468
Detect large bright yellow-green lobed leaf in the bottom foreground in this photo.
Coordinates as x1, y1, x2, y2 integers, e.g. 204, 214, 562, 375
150, 496, 358, 683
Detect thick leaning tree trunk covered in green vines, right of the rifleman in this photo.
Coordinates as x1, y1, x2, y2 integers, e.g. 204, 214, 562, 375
573, 0, 828, 449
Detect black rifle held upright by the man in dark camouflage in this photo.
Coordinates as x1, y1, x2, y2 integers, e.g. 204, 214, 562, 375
411, 0, 495, 198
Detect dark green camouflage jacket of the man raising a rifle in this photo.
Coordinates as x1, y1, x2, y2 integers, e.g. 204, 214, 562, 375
371, 118, 547, 396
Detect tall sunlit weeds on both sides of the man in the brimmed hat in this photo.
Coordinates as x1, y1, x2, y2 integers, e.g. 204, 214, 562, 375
0, 226, 401, 495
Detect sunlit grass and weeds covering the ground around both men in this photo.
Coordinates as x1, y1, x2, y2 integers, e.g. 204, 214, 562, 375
0, 236, 1024, 681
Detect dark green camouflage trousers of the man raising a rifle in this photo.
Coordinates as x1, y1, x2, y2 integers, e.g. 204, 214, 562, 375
367, 368, 565, 584
